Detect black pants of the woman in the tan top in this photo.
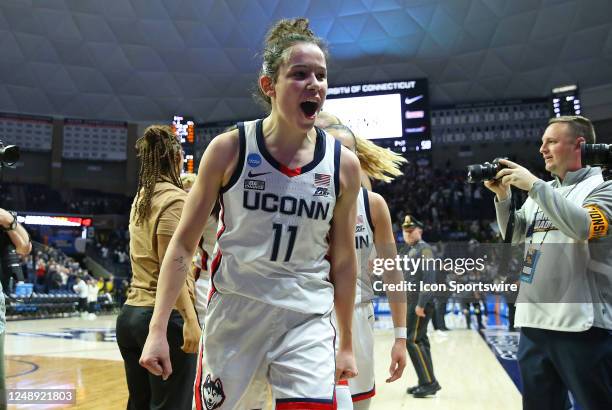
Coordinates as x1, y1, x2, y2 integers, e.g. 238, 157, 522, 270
117, 305, 197, 410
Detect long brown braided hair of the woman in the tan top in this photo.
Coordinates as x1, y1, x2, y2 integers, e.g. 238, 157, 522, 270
134, 125, 183, 225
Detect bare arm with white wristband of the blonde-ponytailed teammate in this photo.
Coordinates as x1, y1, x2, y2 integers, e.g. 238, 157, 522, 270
368, 192, 407, 383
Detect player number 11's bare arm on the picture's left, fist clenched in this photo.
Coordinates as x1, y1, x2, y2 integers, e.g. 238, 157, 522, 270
140, 130, 239, 380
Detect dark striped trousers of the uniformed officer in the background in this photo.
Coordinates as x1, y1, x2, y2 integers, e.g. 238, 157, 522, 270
406, 303, 436, 385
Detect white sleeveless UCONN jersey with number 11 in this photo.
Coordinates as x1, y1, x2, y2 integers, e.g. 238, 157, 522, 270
211, 120, 341, 314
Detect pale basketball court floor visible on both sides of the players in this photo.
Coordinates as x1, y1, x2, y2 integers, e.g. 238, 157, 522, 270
5, 316, 521, 410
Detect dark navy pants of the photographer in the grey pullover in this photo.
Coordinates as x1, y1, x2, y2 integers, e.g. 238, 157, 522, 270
518, 327, 612, 410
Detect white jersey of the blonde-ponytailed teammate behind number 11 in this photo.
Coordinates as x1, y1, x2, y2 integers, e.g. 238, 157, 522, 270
355, 188, 375, 304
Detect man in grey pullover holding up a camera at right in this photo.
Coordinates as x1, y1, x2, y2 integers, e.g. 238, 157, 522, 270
485, 116, 612, 410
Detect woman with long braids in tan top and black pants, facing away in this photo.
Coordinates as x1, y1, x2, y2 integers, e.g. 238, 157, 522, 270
117, 126, 200, 409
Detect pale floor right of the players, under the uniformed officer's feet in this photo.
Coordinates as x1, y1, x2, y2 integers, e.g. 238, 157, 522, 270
370, 329, 522, 410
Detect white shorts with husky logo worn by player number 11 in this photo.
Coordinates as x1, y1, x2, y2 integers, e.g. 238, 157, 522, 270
194, 292, 336, 410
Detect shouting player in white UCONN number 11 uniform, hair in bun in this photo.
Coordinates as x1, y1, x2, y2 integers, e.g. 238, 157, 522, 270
141, 19, 359, 410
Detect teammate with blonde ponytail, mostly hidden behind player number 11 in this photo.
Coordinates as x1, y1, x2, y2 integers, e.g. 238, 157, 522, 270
325, 124, 407, 410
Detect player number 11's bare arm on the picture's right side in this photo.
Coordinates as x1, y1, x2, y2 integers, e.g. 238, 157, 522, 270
329, 147, 360, 380
